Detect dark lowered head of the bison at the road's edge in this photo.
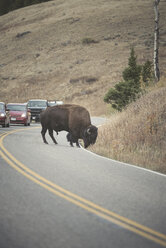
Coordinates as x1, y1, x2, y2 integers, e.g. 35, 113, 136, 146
83, 125, 98, 148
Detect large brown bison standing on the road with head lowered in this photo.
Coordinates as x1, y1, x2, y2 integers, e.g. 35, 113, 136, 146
40, 104, 98, 148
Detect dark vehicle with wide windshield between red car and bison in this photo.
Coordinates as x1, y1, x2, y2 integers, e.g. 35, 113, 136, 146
28, 99, 48, 122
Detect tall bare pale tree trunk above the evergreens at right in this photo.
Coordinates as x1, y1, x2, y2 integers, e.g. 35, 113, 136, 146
154, 0, 160, 82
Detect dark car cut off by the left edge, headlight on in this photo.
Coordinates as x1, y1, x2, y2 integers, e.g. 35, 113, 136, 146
0, 102, 10, 127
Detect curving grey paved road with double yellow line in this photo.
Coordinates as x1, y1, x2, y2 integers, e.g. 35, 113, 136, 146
0, 119, 166, 248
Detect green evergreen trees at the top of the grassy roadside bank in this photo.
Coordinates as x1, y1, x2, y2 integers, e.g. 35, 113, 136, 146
104, 48, 154, 111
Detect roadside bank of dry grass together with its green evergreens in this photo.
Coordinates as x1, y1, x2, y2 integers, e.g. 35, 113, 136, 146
91, 48, 166, 173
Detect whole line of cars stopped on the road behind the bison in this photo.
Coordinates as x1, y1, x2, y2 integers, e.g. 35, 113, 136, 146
0, 99, 63, 127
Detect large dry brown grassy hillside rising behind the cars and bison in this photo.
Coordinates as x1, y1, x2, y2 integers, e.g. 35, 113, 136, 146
0, 0, 166, 115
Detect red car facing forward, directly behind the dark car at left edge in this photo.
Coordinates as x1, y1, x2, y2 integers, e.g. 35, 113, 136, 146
7, 103, 31, 126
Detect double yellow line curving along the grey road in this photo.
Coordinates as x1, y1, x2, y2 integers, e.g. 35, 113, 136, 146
0, 128, 166, 247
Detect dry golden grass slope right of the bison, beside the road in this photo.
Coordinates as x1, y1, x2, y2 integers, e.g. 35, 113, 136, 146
90, 79, 166, 173
